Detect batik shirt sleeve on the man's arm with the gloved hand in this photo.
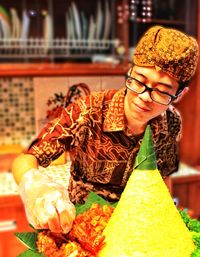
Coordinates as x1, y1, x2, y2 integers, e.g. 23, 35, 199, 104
26, 99, 86, 167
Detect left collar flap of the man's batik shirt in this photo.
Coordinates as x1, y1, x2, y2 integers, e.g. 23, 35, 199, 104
103, 87, 126, 132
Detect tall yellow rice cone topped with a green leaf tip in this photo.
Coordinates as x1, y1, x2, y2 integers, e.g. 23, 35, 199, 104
99, 126, 195, 257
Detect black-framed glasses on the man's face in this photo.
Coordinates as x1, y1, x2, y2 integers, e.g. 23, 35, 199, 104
126, 75, 182, 105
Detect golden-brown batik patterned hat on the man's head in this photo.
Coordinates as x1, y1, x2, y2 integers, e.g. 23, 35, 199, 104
133, 26, 199, 82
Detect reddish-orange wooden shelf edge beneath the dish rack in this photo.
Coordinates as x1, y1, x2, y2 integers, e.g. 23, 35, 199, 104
0, 61, 130, 77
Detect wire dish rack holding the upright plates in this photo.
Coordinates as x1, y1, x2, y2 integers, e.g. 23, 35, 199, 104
0, 38, 118, 59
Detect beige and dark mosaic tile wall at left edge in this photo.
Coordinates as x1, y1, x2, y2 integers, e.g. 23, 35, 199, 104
0, 77, 35, 145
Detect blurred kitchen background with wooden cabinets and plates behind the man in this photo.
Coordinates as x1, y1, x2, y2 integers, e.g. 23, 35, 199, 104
0, 0, 200, 257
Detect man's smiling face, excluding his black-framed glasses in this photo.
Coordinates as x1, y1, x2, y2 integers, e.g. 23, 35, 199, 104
125, 66, 179, 124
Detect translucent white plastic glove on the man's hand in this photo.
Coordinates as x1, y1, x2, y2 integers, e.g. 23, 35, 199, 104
19, 169, 76, 233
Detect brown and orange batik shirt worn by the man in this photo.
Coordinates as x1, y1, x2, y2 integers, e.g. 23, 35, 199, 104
27, 88, 181, 203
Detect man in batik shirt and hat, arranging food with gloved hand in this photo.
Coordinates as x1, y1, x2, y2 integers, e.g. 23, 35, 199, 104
13, 26, 198, 232
